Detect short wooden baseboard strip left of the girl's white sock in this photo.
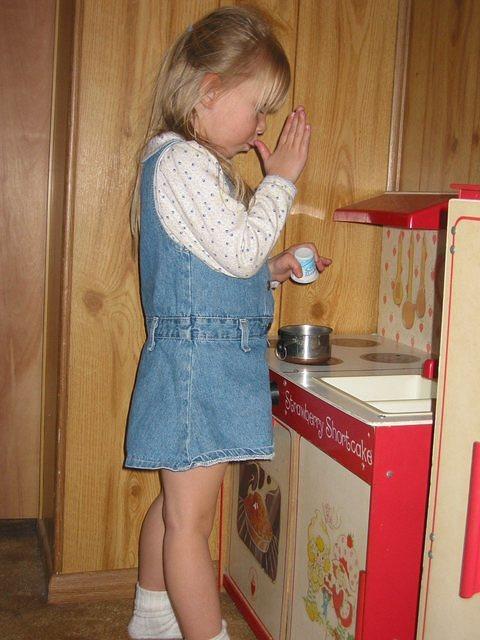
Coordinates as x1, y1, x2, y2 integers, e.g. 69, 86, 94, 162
48, 569, 137, 604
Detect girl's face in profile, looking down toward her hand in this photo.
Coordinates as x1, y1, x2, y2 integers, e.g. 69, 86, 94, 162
196, 78, 266, 158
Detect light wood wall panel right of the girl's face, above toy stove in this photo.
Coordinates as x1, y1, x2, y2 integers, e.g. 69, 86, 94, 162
281, 0, 397, 333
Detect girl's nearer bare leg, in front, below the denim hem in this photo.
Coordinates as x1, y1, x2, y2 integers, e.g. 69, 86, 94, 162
161, 463, 227, 640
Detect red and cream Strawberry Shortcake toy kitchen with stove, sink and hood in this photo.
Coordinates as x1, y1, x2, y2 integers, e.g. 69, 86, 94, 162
222, 185, 480, 640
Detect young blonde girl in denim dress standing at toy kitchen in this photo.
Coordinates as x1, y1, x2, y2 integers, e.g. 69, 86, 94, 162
126, 7, 330, 640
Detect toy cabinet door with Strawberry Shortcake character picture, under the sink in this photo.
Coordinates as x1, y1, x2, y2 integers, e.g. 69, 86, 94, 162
289, 439, 370, 640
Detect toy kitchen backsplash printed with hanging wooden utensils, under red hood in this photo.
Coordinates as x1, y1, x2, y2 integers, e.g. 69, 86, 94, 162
377, 228, 446, 355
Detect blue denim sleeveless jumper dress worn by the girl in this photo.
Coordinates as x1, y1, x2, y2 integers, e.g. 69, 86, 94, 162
125, 140, 273, 471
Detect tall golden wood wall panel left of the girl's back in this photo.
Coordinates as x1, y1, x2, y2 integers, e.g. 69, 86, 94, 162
57, 0, 217, 573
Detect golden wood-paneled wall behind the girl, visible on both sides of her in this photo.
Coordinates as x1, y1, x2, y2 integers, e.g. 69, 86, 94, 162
57, 0, 397, 573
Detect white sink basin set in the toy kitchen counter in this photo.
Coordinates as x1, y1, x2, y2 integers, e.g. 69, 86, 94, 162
315, 375, 437, 414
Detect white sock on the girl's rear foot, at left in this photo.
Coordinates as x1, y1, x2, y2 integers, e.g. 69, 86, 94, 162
128, 584, 182, 640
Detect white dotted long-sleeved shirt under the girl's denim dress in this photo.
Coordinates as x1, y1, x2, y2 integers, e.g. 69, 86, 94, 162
144, 133, 296, 278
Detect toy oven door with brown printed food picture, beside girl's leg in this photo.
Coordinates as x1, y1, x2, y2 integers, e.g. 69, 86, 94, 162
227, 421, 298, 640
